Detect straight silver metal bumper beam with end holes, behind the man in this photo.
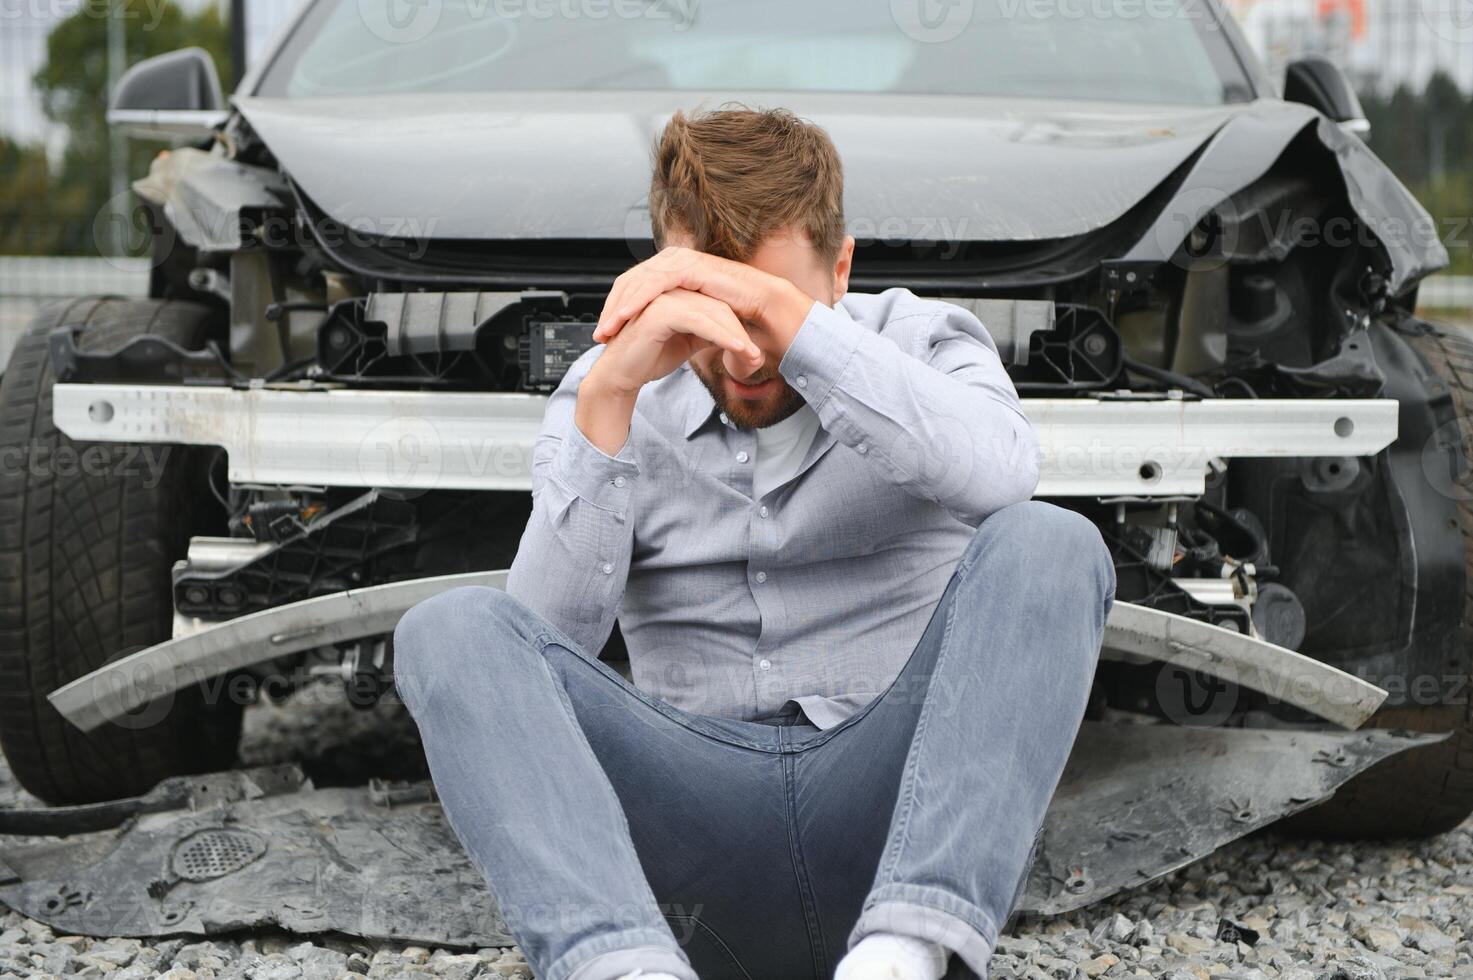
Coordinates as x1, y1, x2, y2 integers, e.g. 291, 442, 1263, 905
53, 385, 1396, 497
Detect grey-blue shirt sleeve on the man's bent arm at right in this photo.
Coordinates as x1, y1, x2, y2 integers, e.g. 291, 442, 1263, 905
778, 297, 1038, 526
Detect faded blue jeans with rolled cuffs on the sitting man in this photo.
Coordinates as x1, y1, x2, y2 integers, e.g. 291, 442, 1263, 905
395, 501, 1115, 980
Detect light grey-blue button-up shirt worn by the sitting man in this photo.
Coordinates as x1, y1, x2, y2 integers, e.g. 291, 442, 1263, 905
507, 289, 1038, 728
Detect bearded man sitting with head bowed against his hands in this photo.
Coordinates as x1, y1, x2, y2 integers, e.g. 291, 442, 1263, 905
395, 111, 1115, 980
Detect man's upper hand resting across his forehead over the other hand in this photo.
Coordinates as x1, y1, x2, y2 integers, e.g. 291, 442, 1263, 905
594, 248, 813, 351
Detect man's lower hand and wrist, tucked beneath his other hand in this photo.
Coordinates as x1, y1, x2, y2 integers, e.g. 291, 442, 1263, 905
573, 289, 764, 455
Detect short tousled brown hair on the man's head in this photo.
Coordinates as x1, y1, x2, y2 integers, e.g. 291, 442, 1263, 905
650, 106, 844, 262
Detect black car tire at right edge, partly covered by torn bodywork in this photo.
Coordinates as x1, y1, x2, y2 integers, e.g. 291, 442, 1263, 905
1286, 322, 1473, 840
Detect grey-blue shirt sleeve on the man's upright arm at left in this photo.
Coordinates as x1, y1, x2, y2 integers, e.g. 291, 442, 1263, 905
507, 346, 639, 654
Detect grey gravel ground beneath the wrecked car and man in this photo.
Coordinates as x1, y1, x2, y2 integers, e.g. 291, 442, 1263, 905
0, 685, 1473, 980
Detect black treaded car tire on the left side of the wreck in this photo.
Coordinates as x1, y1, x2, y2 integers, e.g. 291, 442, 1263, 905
0, 298, 242, 803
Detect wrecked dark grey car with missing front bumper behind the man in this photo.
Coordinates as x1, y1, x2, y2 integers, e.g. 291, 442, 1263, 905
0, 0, 1473, 945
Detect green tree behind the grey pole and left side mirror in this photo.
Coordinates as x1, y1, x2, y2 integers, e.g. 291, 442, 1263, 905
32, 0, 228, 255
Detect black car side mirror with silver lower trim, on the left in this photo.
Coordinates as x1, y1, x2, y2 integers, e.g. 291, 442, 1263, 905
108, 47, 225, 139
